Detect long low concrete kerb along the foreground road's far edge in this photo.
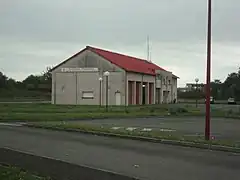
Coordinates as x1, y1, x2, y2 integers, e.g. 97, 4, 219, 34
23, 124, 240, 153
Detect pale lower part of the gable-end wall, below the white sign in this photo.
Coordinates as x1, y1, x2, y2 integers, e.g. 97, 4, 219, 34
52, 72, 125, 105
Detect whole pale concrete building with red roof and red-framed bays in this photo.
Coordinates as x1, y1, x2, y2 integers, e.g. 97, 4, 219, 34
51, 46, 178, 105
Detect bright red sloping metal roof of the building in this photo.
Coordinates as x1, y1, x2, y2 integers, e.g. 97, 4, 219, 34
87, 46, 166, 75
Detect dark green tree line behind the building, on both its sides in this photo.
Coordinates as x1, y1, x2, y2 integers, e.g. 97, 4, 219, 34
0, 67, 240, 101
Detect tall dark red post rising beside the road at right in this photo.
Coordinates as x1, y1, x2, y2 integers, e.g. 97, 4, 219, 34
205, 0, 212, 140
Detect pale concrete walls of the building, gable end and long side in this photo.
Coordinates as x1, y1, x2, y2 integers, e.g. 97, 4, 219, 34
52, 50, 177, 105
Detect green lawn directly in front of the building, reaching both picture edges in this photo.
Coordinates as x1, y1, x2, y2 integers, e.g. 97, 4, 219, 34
0, 103, 240, 121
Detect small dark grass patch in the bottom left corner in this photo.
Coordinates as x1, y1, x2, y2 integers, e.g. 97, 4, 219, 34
0, 165, 50, 180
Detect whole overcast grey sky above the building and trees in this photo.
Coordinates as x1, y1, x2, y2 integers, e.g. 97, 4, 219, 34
0, 0, 240, 86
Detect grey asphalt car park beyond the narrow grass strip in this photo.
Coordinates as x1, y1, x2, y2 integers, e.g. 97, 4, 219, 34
70, 117, 240, 142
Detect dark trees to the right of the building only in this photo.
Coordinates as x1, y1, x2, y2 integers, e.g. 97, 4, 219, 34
178, 68, 240, 101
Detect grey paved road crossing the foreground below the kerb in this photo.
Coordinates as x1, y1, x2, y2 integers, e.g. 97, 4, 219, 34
0, 126, 240, 180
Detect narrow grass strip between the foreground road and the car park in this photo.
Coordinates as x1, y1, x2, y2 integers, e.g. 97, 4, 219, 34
27, 122, 240, 148
